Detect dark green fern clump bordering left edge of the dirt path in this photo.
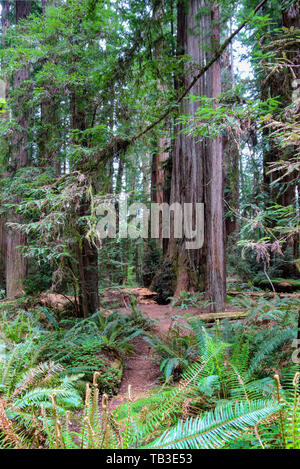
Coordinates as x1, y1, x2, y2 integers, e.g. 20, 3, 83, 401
37, 313, 141, 393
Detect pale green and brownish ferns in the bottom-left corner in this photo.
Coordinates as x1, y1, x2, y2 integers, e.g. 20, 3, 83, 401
0, 339, 81, 445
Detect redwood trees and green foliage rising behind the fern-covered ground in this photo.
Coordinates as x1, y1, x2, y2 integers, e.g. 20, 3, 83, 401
0, 1, 300, 315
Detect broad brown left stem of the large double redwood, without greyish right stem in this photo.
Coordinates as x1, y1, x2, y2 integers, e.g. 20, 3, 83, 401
168, 0, 206, 296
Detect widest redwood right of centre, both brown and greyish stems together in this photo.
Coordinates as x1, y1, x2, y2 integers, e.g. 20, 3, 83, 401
169, 0, 225, 311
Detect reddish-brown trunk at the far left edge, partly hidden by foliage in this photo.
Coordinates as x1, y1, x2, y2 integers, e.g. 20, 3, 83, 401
6, 0, 31, 298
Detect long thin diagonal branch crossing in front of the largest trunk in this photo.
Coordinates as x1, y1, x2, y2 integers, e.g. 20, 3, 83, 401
78, 0, 267, 171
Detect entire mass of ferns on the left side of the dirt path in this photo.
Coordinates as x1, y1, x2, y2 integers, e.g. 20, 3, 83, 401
0, 302, 149, 446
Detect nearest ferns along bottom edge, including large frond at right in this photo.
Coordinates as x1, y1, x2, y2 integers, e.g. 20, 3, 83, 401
44, 362, 299, 449
